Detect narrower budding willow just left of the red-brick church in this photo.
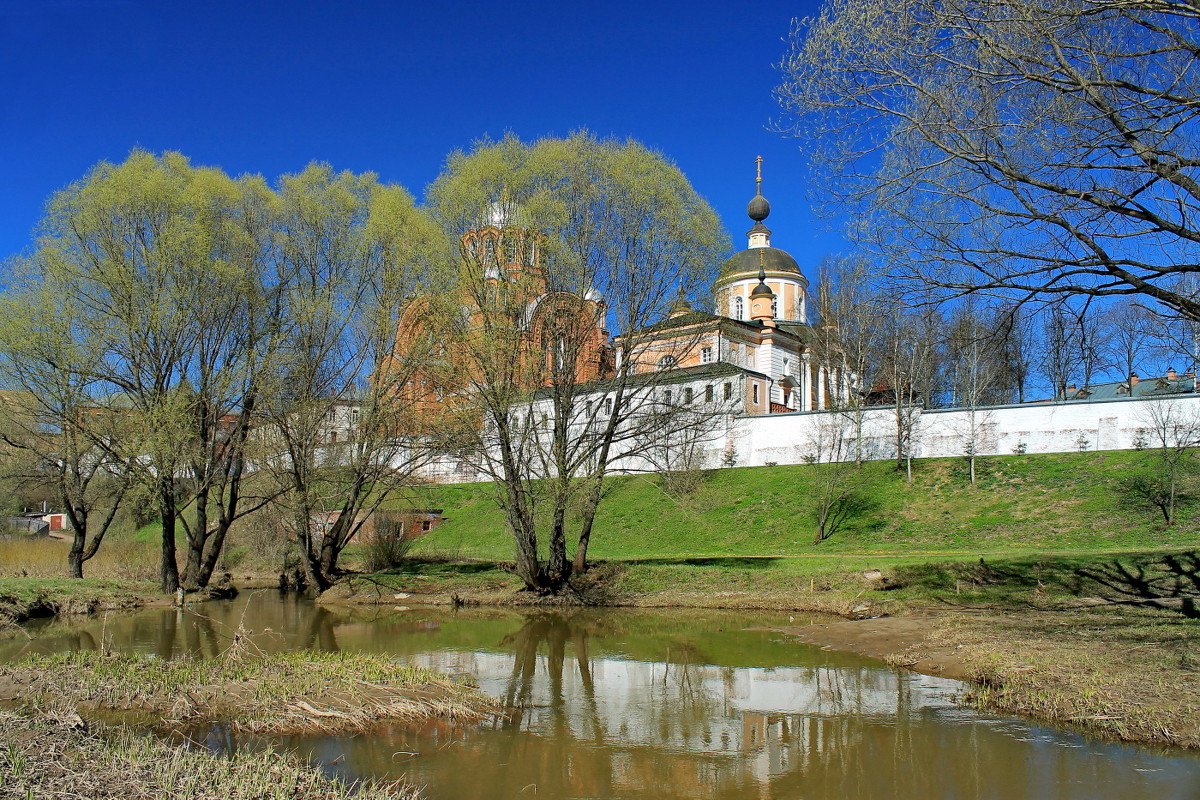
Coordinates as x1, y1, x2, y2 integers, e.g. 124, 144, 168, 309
259, 164, 445, 591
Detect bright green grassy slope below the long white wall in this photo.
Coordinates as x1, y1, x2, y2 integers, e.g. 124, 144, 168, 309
408, 452, 1200, 560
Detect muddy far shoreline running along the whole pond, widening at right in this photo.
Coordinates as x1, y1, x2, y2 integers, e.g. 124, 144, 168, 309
4, 581, 1200, 748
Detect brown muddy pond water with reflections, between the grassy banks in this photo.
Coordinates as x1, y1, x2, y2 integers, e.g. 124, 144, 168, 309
7, 593, 1200, 800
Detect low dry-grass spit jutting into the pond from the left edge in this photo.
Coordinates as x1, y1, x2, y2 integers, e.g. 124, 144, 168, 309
0, 645, 499, 733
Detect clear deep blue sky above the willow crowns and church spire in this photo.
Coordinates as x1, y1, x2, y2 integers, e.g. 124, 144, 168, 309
0, 0, 846, 268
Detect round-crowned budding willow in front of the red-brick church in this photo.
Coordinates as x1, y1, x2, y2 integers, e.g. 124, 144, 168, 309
428, 133, 728, 593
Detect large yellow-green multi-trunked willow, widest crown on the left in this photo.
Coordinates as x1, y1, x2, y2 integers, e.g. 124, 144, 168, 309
25, 151, 277, 593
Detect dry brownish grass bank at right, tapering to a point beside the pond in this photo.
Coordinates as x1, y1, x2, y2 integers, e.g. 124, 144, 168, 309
778, 604, 1200, 748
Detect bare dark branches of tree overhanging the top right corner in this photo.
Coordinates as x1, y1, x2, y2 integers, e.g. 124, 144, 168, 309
778, 0, 1200, 320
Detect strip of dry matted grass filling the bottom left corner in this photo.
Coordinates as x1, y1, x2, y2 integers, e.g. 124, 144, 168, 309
0, 712, 420, 800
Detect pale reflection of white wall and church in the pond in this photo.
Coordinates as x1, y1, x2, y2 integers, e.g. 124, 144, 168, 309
408, 652, 958, 788
